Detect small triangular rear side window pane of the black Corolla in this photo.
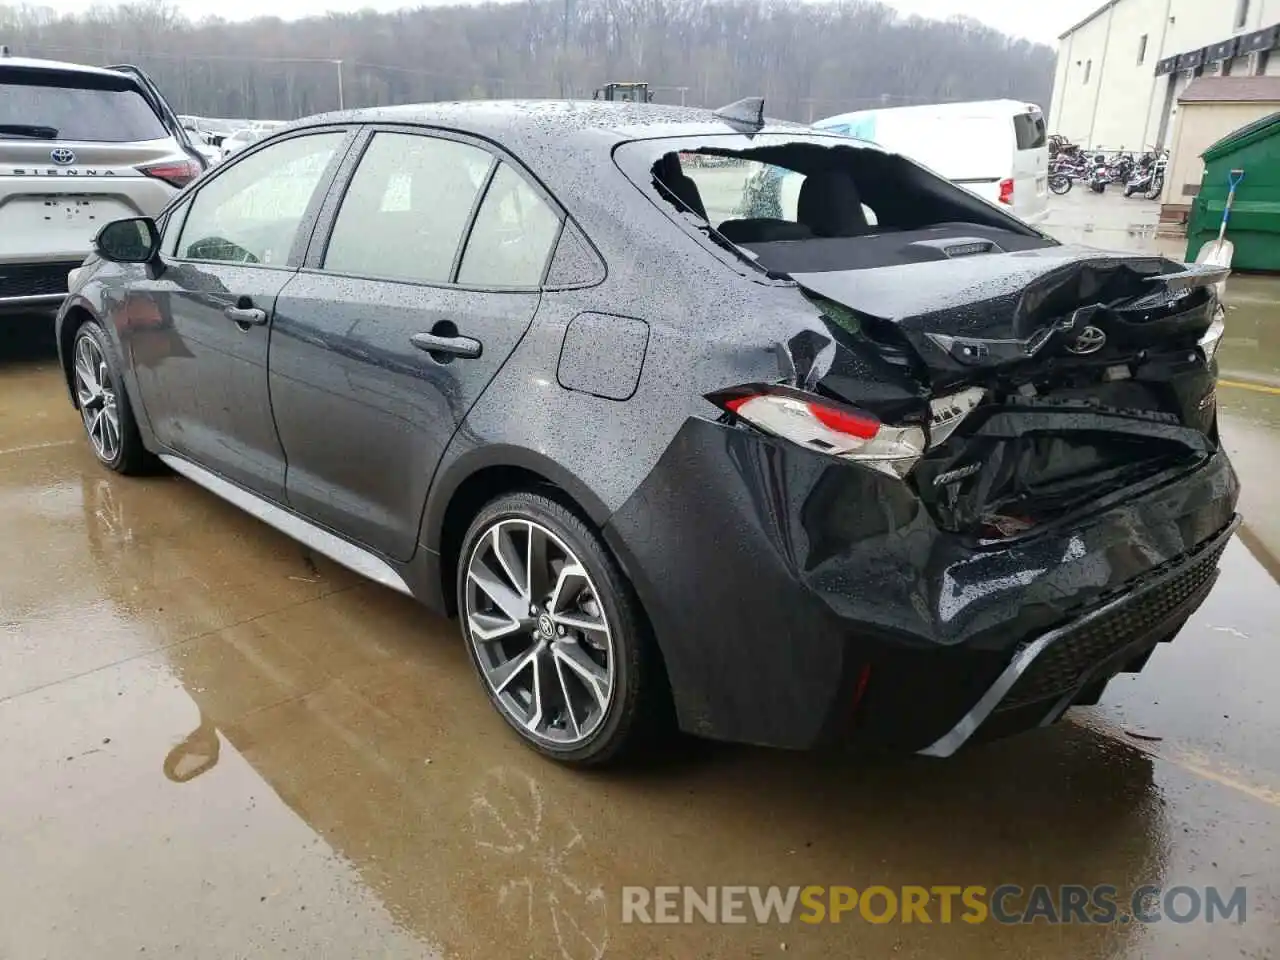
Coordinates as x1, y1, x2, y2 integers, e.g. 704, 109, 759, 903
458, 164, 559, 287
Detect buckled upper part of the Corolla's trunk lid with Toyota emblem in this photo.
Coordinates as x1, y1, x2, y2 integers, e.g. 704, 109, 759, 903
791, 246, 1226, 385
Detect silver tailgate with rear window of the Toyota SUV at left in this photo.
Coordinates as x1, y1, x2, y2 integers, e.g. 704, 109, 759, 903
0, 60, 192, 272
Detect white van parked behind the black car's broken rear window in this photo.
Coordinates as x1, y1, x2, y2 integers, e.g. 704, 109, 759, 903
813, 100, 1048, 223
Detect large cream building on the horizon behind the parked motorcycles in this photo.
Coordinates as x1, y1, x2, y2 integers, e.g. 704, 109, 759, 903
1048, 0, 1280, 152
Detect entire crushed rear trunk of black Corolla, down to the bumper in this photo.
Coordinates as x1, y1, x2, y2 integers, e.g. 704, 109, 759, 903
794, 247, 1225, 540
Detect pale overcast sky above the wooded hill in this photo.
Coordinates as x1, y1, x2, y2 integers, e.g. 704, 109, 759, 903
45, 0, 1095, 45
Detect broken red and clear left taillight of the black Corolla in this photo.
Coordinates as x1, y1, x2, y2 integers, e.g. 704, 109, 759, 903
708, 384, 924, 477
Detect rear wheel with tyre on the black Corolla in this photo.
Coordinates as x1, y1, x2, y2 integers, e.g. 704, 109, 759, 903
457, 492, 662, 765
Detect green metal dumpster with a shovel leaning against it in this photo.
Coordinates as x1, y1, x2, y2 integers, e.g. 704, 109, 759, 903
1187, 113, 1280, 270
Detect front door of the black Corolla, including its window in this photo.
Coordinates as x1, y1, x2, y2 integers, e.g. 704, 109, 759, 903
128, 131, 348, 499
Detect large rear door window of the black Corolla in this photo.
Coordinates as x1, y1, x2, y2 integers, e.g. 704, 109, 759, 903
323, 133, 493, 283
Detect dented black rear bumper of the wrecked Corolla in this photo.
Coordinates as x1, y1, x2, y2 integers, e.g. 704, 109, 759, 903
605, 419, 1238, 755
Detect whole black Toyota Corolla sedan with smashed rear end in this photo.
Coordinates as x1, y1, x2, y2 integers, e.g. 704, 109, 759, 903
58, 101, 1238, 763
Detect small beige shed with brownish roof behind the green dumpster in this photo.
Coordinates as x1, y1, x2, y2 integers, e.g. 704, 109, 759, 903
1161, 77, 1280, 220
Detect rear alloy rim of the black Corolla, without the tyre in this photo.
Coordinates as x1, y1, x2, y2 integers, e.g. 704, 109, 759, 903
463, 518, 616, 748
